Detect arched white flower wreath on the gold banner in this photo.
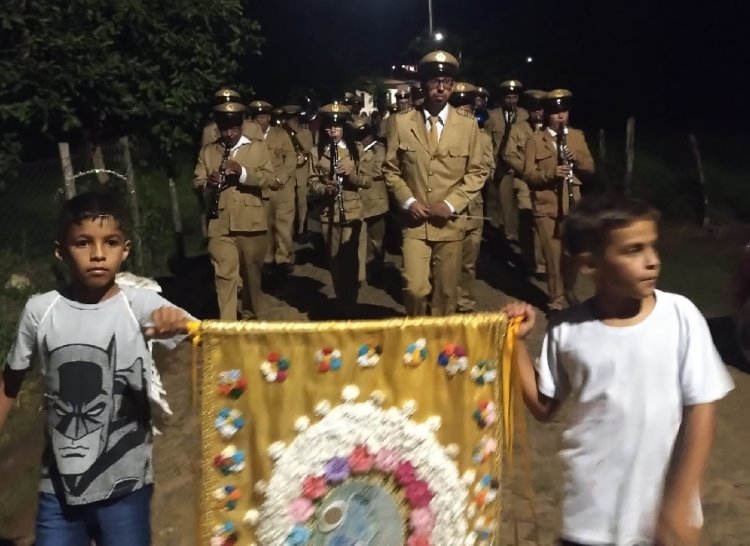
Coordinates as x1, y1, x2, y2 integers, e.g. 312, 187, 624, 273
256, 394, 469, 546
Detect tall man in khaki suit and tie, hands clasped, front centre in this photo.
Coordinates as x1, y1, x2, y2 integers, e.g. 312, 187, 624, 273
383, 51, 488, 316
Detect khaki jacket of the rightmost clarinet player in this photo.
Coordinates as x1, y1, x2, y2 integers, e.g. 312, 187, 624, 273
523, 128, 594, 218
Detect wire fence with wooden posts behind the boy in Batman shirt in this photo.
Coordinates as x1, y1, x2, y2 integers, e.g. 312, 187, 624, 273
0, 142, 209, 276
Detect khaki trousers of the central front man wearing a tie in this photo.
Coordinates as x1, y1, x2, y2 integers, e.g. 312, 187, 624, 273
402, 237, 463, 317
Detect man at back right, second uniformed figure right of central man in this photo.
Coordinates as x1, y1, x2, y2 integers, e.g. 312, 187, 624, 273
487, 80, 528, 242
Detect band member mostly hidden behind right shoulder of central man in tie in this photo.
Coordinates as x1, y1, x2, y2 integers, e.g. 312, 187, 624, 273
450, 82, 495, 313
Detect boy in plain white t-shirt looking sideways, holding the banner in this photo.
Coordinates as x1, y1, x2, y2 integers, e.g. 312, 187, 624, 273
505, 196, 733, 546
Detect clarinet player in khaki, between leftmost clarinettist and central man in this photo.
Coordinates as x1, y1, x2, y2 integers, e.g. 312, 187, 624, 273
309, 102, 371, 318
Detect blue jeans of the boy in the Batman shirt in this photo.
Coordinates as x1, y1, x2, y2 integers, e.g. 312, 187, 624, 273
35, 485, 153, 546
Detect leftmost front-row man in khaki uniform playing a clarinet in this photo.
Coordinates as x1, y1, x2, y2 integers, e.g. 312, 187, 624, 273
193, 102, 276, 320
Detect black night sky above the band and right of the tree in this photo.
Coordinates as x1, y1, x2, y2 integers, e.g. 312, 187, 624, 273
245, 0, 748, 129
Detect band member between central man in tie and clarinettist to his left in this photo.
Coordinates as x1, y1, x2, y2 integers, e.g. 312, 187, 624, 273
352, 120, 388, 278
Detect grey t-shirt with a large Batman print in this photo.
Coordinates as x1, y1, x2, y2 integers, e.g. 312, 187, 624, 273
8, 287, 185, 505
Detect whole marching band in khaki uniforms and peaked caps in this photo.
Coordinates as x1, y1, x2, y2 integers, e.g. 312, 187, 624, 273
195, 50, 594, 320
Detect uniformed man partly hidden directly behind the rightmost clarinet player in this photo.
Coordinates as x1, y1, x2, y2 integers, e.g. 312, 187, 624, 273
503, 89, 546, 274
